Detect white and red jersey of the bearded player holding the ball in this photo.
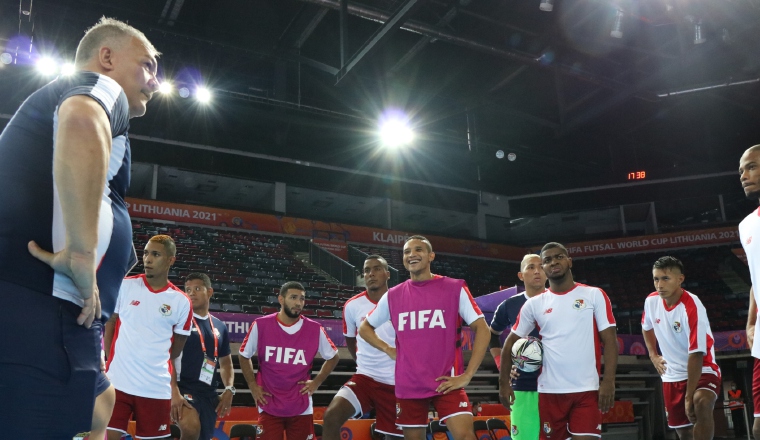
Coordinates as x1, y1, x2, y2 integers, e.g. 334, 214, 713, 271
512, 283, 615, 394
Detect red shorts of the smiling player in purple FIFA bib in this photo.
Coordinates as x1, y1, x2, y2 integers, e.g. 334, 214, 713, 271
396, 389, 472, 428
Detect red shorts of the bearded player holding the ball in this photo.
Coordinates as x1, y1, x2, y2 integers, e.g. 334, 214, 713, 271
538, 391, 602, 440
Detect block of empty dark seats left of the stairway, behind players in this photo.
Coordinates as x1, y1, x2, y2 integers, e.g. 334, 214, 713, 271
131, 221, 363, 318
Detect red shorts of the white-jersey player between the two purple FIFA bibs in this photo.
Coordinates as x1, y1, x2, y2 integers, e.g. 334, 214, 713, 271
337, 374, 404, 436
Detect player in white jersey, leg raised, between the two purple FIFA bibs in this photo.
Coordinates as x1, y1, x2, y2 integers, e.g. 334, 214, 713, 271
322, 255, 403, 440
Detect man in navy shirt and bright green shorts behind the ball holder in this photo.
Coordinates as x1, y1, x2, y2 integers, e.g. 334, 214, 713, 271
491, 254, 546, 440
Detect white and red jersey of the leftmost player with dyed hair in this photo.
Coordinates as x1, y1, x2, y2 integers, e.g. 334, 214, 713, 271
106, 275, 193, 399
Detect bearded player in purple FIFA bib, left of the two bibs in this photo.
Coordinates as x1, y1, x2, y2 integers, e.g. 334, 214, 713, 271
239, 281, 339, 440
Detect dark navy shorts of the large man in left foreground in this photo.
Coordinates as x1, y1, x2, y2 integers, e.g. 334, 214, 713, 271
0, 281, 101, 440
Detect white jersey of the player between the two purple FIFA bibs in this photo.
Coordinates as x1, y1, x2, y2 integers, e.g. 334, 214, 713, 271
343, 291, 396, 385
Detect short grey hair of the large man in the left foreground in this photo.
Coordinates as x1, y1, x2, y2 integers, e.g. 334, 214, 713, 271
74, 17, 161, 67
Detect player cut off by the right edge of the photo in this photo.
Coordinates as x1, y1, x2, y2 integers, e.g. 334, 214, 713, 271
739, 145, 760, 438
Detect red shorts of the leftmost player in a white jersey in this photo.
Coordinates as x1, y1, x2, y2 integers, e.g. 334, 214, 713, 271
108, 390, 172, 438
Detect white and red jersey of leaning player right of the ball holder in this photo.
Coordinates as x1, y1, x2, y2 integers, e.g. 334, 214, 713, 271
641, 290, 720, 382
